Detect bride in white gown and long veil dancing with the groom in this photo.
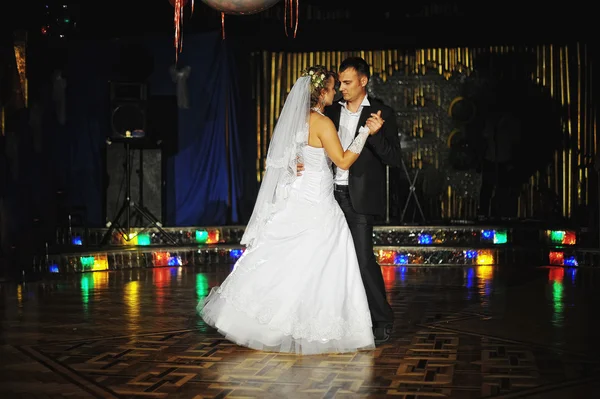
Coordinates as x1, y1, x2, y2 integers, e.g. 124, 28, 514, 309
197, 66, 381, 355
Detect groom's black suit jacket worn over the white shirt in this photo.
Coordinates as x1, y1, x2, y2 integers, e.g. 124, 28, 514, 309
325, 97, 401, 216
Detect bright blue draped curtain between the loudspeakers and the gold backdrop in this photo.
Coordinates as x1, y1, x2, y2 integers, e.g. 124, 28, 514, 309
150, 32, 256, 226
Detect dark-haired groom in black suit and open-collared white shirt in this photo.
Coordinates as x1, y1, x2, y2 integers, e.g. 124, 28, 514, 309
325, 57, 401, 343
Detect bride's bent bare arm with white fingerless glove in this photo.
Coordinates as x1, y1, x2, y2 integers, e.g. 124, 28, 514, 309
315, 118, 369, 170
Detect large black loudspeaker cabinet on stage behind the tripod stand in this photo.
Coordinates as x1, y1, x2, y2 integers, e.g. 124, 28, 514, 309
105, 143, 164, 227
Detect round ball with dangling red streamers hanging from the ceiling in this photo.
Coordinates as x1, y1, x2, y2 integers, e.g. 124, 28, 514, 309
169, 0, 299, 56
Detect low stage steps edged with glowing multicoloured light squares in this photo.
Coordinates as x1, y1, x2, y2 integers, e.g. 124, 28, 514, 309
34, 223, 584, 274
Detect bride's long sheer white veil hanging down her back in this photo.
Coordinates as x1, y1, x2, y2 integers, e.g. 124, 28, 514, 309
241, 76, 311, 247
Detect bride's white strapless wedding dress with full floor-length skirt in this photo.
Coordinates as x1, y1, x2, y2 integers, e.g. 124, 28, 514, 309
198, 146, 375, 355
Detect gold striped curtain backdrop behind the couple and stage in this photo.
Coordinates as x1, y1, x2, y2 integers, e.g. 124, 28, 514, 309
252, 43, 597, 219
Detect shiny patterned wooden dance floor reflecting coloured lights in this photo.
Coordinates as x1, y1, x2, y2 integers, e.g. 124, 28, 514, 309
0, 266, 600, 398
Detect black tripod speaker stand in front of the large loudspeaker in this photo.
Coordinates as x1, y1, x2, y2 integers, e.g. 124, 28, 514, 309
100, 139, 178, 245
